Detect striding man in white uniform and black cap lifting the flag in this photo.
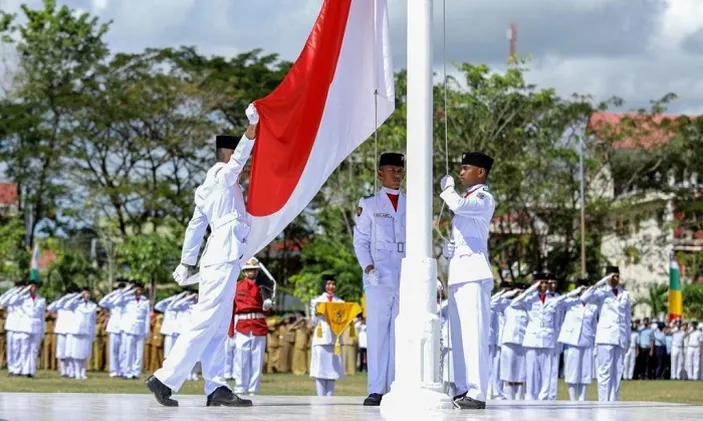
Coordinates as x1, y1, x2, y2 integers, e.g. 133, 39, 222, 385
146, 104, 259, 406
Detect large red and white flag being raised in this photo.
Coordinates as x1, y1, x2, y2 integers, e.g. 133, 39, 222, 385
244, 0, 395, 259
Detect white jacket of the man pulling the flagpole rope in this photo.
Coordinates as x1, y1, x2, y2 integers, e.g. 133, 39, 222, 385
439, 184, 496, 285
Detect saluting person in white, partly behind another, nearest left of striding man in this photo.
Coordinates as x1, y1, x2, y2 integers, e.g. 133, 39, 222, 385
97, 281, 131, 377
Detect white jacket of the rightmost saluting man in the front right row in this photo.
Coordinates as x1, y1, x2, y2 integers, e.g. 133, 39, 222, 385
581, 285, 632, 350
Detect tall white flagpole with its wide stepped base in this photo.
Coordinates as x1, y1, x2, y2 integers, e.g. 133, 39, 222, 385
381, 0, 452, 412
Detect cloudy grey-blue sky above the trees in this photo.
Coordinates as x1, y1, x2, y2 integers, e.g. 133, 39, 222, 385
0, 0, 703, 113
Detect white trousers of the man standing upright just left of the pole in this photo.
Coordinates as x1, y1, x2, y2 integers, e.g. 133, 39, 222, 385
365, 285, 398, 395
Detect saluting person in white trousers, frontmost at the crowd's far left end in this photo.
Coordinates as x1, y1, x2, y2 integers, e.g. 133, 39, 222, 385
8, 281, 46, 377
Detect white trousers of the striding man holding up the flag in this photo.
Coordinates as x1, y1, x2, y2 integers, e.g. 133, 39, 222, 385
154, 261, 239, 395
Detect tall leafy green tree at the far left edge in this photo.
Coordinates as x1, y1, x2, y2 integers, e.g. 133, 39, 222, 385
0, 0, 109, 247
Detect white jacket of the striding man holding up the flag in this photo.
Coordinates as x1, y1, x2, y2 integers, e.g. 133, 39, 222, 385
181, 135, 254, 267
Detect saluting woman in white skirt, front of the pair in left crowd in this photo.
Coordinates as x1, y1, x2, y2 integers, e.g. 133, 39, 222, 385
66, 288, 98, 380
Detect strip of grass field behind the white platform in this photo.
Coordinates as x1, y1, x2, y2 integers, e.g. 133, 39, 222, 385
0, 370, 703, 405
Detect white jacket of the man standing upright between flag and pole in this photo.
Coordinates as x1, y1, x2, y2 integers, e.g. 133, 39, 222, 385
354, 188, 405, 289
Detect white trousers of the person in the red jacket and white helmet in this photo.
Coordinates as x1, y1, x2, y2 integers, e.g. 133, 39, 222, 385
234, 332, 266, 395
